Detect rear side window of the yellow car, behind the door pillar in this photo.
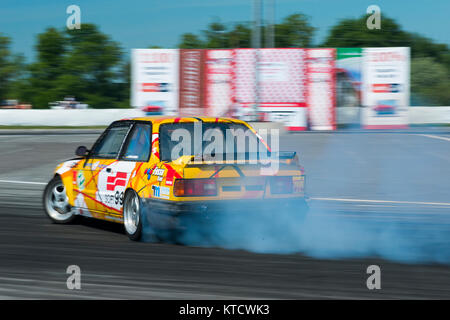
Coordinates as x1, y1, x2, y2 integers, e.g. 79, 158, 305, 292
121, 123, 152, 162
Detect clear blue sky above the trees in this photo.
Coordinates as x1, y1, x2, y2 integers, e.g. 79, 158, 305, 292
0, 0, 450, 60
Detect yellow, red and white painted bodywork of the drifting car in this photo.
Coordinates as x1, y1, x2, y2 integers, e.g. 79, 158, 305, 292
44, 117, 305, 240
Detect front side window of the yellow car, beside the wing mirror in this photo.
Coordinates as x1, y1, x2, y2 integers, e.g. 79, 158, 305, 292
91, 124, 130, 159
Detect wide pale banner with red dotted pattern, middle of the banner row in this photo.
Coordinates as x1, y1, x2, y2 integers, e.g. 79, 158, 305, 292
232, 48, 306, 130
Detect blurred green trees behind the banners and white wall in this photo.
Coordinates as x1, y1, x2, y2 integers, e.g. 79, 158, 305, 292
0, 13, 450, 108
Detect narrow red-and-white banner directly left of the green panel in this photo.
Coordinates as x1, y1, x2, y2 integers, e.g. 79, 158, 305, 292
307, 49, 336, 130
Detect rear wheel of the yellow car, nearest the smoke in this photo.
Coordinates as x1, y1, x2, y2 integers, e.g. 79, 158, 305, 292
123, 190, 142, 241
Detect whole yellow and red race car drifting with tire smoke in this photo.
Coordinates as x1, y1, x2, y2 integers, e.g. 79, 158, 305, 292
43, 117, 307, 240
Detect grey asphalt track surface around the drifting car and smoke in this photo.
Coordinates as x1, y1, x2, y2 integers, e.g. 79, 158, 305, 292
0, 130, 450, 299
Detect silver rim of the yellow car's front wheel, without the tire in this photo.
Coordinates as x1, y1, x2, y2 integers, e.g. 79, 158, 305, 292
45, 182, 72, 221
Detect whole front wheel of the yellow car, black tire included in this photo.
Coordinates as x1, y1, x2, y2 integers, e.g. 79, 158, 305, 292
42, 176, 78, 224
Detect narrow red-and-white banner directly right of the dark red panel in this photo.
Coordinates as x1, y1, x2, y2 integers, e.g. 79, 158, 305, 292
205, 50, 232, 117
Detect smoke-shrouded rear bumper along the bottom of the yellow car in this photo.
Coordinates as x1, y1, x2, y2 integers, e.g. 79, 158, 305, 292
142, 198, 309, 229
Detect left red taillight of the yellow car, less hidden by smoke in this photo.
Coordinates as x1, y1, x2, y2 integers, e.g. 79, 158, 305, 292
173, 179, 217, 197
